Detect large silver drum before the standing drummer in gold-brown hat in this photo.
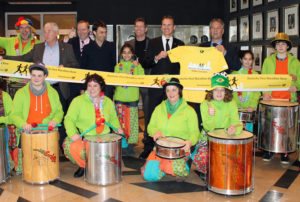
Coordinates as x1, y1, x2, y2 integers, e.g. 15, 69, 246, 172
258, 100, 299, 153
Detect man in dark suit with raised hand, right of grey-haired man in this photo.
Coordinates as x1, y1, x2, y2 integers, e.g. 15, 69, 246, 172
64, 20, 91, 105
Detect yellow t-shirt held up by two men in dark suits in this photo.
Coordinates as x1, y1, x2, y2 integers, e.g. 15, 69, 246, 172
168, 46, 228, 75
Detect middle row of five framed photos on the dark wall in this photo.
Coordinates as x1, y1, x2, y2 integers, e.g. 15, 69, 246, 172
228, 4, 299, 42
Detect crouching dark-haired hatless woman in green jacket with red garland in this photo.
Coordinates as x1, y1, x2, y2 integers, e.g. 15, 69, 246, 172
63, 74, 123, 177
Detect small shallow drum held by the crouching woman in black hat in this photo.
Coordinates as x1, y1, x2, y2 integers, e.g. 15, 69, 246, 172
155, 137, 185, 159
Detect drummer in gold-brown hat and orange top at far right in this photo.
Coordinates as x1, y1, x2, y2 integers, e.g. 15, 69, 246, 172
261, 33, 300, 164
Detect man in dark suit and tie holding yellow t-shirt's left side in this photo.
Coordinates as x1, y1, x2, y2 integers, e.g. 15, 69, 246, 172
140, 16, 184, 158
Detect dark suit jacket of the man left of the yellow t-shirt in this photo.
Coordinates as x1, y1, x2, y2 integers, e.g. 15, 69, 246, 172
146, 36, 184, 75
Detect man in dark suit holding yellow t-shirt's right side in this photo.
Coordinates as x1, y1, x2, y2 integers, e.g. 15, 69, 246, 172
200, 18, 241, 73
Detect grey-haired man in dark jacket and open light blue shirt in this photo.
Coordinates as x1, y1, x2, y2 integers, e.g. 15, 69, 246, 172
0, 22, 78, 151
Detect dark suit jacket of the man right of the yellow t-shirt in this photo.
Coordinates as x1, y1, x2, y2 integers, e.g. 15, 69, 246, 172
200, 41, 242, 73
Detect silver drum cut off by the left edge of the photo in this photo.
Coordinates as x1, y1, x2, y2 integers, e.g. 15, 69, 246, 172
0, 127, 9, 183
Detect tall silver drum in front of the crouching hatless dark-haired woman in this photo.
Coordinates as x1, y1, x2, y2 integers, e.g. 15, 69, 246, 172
85, 133, 122, 185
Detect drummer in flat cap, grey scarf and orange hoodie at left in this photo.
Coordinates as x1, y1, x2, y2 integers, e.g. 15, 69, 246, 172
9, 63, 64, 172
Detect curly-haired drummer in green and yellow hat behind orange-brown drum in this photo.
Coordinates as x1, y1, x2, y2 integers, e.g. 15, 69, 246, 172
192, 72, 243, 180
